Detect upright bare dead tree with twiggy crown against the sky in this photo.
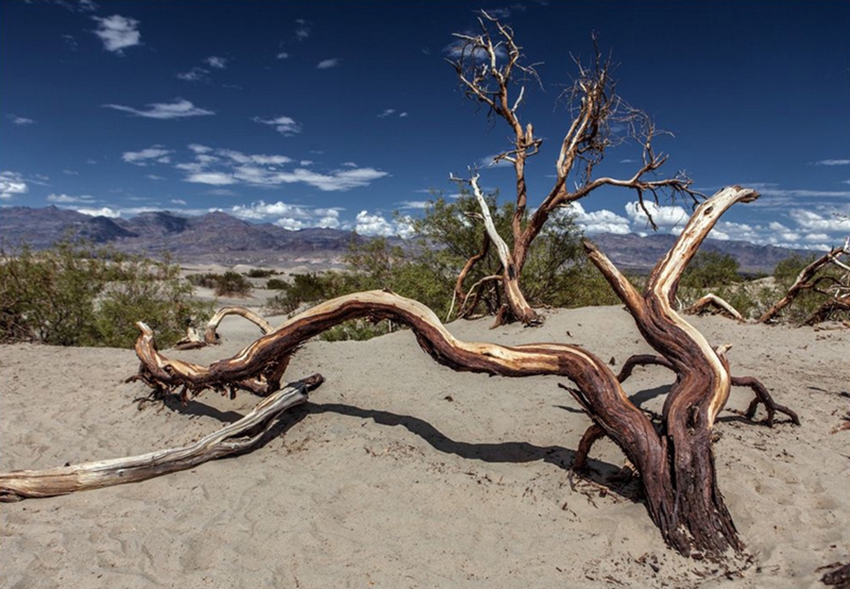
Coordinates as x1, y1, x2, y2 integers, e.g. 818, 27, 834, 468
449, 11, 698, 325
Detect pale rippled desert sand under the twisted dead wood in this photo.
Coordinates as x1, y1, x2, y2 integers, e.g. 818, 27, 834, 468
0, 296, 850, 589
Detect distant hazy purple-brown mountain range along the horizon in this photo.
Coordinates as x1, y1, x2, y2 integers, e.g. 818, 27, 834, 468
0, 206, 806, 273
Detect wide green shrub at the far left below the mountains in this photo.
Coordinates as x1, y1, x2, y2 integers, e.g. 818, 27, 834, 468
0, 242, 212, 347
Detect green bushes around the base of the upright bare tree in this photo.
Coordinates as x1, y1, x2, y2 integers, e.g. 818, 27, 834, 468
265, 193, 618, 340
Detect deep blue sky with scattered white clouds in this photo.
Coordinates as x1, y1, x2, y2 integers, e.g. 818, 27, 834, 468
0, 0, 850, 248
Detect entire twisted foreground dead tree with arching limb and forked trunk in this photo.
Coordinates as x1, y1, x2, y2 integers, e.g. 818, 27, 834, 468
0, 187, 796, 558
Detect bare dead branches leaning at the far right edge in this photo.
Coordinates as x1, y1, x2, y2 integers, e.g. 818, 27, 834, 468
758, 237, 850, 324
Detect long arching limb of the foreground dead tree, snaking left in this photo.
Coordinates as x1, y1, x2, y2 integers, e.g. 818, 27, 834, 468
136, 291, 700, 556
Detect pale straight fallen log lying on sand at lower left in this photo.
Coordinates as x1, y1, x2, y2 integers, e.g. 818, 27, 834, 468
0, 374, 322, 502
